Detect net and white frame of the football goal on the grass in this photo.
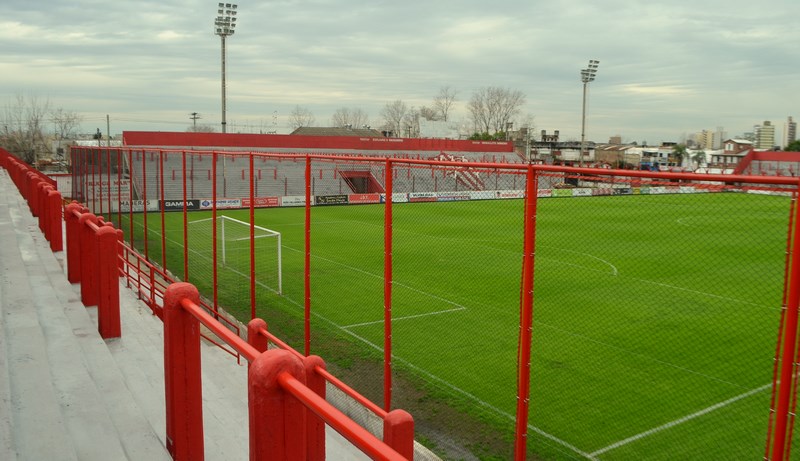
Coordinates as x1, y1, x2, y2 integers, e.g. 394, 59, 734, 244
188, 215, 283, 295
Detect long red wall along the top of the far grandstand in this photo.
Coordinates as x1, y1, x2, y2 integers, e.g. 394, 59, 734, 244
122, 131, 514, 152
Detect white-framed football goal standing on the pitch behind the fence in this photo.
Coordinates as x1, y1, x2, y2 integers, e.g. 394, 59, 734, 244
188, 215, 283, 295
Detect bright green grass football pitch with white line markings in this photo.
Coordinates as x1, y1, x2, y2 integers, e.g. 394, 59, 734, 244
121, 193, 791, 460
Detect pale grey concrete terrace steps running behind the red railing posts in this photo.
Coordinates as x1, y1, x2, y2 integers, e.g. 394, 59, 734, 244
0, 169, 374, 461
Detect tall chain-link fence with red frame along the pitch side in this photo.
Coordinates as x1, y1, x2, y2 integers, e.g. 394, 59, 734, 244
73, 149, 800, 459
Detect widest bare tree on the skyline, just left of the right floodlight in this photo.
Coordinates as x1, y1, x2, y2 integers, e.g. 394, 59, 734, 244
467, 86, 525, 133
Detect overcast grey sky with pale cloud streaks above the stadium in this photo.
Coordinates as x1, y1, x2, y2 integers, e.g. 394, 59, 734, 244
0, 0, 800, 144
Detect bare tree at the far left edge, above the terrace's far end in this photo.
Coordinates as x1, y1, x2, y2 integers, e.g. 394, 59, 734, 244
2, 94, 50, 164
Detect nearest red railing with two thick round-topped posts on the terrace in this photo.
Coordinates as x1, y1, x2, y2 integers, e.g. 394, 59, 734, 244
164, 282, 413, 460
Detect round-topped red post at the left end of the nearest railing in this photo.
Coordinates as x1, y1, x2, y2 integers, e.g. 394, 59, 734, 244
164, 282, 205, 461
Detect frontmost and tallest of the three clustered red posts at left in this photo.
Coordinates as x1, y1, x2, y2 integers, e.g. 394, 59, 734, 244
97, 224, 122, 339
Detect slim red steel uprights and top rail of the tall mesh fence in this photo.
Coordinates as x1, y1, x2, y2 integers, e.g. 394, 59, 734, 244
61, 149, 800, 460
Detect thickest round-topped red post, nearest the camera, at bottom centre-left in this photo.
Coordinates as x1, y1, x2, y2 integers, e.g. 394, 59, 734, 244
247, 349, 306, 461
